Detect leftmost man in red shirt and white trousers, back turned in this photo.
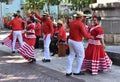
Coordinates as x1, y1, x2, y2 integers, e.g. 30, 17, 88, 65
7, 13, 24, 53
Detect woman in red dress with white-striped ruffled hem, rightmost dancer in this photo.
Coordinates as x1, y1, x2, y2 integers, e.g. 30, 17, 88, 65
82, 16, 112, 75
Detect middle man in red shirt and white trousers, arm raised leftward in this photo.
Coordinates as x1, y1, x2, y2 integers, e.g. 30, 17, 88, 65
32, 12, 54, 62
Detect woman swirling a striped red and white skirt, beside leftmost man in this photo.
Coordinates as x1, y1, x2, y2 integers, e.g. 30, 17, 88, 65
18, 18, 36, 63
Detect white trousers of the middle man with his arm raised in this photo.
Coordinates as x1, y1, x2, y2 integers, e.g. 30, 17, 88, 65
43, 34, 51, 59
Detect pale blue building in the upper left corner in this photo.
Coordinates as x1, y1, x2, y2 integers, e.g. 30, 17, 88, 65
0, 0, 25, 28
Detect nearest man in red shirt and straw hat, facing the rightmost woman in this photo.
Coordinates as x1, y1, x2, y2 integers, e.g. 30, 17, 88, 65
66, 12, 92, 76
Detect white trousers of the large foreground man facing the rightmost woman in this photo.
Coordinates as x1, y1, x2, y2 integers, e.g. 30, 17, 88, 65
66, 39, 85, 73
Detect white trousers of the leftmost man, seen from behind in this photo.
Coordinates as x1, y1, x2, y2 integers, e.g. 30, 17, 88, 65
12, 31, 24, 51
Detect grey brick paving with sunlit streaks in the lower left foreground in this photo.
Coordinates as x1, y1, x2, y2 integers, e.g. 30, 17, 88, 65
0, 50, 85, 82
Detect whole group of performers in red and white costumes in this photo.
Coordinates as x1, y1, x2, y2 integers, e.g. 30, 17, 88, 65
2, 12, 112, 76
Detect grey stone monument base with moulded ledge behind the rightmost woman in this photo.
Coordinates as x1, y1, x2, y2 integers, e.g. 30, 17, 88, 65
90, 0, 120, 44
